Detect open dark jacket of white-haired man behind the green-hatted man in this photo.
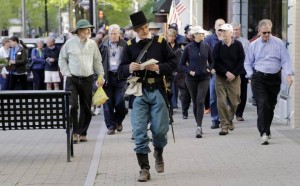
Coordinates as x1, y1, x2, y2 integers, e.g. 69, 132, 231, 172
99, 39, 127, 83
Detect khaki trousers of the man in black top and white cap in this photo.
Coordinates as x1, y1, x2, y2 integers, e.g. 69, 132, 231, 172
215, 75, 241, 130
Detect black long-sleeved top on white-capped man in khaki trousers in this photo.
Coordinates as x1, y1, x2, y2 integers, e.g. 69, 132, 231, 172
213, 40, 245, 78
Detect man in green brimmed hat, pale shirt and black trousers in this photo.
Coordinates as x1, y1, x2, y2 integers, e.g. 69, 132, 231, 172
58, 19, 104, 143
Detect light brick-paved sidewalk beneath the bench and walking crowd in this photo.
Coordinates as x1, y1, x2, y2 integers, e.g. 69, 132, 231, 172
0, 107, 300, 186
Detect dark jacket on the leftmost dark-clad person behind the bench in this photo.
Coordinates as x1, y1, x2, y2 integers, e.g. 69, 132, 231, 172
6, 46, 28, 74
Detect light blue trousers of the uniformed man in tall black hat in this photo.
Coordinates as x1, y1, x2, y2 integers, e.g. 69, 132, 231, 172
131, 89, 169, 154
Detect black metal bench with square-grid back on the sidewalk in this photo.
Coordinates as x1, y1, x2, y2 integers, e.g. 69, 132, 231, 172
0, 90, 73, 162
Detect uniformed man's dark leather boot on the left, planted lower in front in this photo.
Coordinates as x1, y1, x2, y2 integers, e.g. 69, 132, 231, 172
136, 153, 150, 182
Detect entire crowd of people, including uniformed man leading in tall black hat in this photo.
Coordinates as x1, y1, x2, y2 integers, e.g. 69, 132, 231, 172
0, 11, 294, 182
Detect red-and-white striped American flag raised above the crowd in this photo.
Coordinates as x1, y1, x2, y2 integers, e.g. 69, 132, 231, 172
168, 0, 186, 27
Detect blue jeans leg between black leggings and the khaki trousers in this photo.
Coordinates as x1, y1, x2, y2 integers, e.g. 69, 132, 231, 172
209, 74, 220, 123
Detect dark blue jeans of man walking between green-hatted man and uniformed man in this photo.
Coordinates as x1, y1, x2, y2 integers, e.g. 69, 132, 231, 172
103, 76, 128, 129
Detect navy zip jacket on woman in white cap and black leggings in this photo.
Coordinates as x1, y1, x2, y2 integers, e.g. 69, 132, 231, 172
179, 41, 214, 80
